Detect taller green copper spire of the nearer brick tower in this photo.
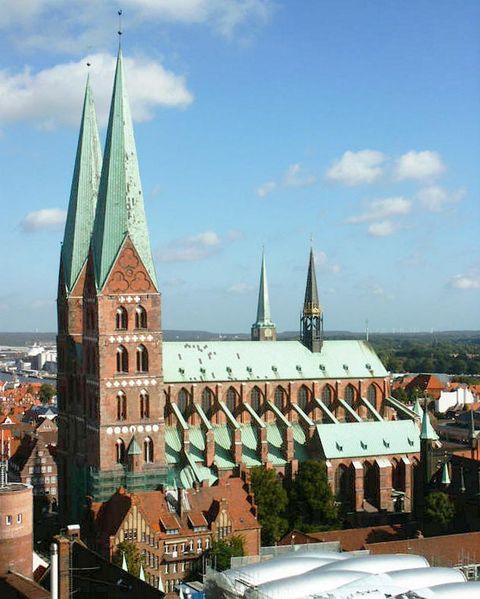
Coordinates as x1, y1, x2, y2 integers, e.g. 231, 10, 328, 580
92, 50, 157, 289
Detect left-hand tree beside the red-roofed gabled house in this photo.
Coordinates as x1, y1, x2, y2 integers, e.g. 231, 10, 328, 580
250, 466, 288, 545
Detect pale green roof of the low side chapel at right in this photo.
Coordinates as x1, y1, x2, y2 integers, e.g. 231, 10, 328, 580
316, 420, 420, 460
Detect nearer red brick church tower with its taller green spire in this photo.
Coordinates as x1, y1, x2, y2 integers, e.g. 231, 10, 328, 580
61, 50, 167, 519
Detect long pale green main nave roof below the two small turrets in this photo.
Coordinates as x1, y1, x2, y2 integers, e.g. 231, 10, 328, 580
163, 340, 387, 383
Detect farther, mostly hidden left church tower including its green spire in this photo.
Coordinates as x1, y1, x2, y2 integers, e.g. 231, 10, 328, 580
57, 80, 102, 514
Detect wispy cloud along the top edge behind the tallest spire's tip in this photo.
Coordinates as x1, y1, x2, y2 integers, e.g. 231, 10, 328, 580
0, 0, 275, 53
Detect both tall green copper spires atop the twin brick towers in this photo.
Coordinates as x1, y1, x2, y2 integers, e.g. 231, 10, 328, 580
61, 49, 157, 294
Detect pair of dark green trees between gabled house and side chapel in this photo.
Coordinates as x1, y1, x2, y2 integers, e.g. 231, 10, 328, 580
251, 460, 340, 545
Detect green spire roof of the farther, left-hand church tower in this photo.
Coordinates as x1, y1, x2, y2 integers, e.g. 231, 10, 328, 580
61, 79, 102, 293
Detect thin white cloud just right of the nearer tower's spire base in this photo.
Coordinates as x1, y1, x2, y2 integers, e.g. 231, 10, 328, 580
156, 231, 233, 262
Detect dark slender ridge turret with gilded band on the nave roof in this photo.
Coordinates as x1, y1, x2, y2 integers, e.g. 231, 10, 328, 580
300, 248, 323, 352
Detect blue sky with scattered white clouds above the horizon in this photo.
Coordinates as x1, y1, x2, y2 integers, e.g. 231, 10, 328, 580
0, 0, 480, 333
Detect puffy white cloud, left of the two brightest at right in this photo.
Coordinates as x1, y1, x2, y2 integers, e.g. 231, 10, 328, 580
325, 150, 386, 185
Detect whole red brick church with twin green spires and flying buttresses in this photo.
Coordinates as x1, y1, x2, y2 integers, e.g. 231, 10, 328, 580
58, 51, 420, 521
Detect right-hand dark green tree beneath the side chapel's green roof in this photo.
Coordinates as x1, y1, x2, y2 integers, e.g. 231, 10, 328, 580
289, 460, 339, 532
